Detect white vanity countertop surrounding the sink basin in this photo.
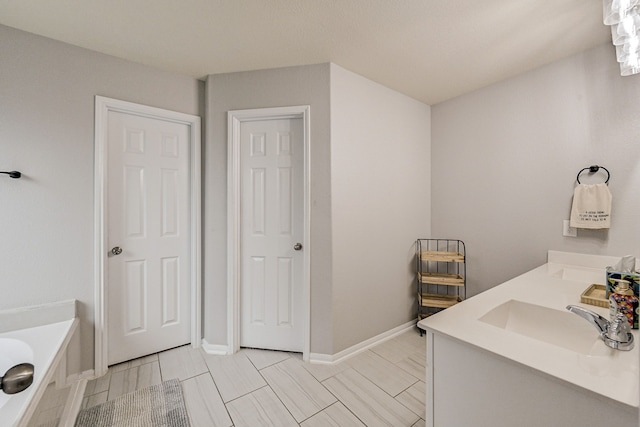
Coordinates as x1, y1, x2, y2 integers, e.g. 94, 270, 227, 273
418, 251, 640, 408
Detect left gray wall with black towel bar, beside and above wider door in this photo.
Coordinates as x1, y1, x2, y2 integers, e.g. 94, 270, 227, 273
0, 26, 204, 370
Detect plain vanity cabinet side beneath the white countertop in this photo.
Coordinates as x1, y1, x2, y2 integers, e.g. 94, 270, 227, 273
425, 331, 638, 427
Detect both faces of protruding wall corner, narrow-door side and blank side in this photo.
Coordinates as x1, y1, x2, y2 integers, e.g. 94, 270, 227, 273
204, 64, 430, 358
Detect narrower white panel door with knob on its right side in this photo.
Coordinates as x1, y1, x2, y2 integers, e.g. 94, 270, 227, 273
240, 118, 304, 352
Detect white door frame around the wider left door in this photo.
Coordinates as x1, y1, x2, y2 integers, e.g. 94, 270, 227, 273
94, 96, 202, 377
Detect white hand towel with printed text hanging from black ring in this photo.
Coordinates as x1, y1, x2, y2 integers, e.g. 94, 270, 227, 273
570, 184, 611, 229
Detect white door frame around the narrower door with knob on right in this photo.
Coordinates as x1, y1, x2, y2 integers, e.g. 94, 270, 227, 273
227, 105, 311, 361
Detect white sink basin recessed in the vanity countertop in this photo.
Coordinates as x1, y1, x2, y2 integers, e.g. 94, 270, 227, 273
478, 300, 615, 356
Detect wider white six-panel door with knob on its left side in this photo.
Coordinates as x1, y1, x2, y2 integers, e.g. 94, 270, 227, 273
106, 111, 191, 365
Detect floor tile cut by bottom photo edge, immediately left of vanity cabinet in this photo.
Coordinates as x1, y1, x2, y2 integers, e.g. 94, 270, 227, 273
322, 369, 419, 427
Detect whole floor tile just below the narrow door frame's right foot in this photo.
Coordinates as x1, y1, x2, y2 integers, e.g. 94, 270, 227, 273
260, 359, 336, 422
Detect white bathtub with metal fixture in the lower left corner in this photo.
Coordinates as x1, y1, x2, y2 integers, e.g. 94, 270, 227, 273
0, 302, 78, 427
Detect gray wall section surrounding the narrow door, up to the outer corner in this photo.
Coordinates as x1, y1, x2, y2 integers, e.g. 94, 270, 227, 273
203, 64, 332, 354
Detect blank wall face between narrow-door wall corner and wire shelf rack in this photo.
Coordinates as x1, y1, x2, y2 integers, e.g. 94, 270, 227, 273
331, 64, 431, 354
